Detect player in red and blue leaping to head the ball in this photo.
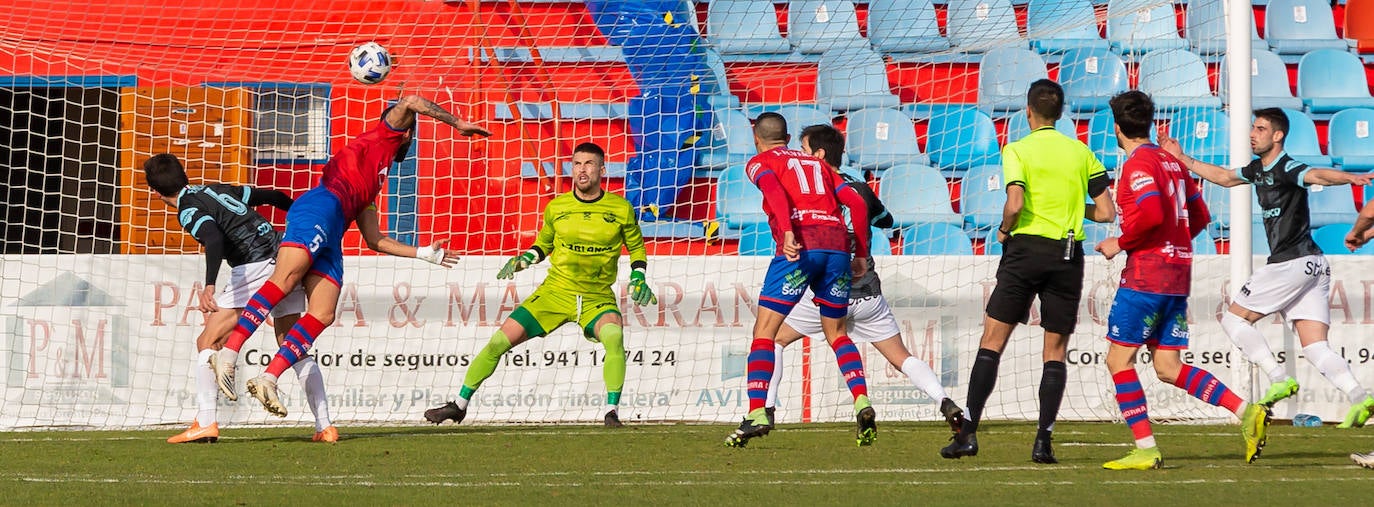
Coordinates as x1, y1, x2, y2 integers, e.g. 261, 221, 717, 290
212, 95, 491, 416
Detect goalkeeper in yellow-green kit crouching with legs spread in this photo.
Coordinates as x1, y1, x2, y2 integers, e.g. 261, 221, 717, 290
425, 143, 658, 427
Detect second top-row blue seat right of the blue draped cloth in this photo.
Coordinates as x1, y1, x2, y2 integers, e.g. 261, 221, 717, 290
787, 0, 868, 55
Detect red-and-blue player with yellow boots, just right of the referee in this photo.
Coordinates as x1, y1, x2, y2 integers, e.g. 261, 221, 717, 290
1096, 91, 1268, 470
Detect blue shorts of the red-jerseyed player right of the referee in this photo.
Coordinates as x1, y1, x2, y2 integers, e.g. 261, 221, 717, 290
1107, 289, 1189, 350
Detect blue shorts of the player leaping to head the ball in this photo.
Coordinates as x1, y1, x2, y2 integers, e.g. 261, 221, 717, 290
282, 187, 349, 286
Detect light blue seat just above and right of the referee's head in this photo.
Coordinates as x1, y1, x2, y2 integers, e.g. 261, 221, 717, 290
1059, 48, 1131, 113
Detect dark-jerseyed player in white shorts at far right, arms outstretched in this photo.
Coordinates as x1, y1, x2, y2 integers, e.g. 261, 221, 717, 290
1160, 107, 1374, 427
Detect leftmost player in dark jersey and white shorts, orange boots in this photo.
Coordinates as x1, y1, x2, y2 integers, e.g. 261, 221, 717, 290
143, 154, 338, 444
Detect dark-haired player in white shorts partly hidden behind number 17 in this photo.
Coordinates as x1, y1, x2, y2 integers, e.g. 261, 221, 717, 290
765, 125, 963, 431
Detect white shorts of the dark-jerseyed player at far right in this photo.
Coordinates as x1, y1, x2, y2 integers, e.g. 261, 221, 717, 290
1235, 256, 1331, 324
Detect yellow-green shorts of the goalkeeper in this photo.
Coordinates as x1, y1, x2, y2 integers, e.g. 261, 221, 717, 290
511, 286, 620, 341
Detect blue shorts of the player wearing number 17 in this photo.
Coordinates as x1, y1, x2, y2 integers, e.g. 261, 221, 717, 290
758, 250, 852, 319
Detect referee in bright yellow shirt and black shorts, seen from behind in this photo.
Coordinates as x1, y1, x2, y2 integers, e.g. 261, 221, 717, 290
940, 80, 1116, 463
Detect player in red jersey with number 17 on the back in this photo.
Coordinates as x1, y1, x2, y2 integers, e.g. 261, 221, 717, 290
725, 113, 878, 447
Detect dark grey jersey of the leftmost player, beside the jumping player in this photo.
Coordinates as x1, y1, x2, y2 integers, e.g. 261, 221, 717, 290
176, 184, 282, 267
